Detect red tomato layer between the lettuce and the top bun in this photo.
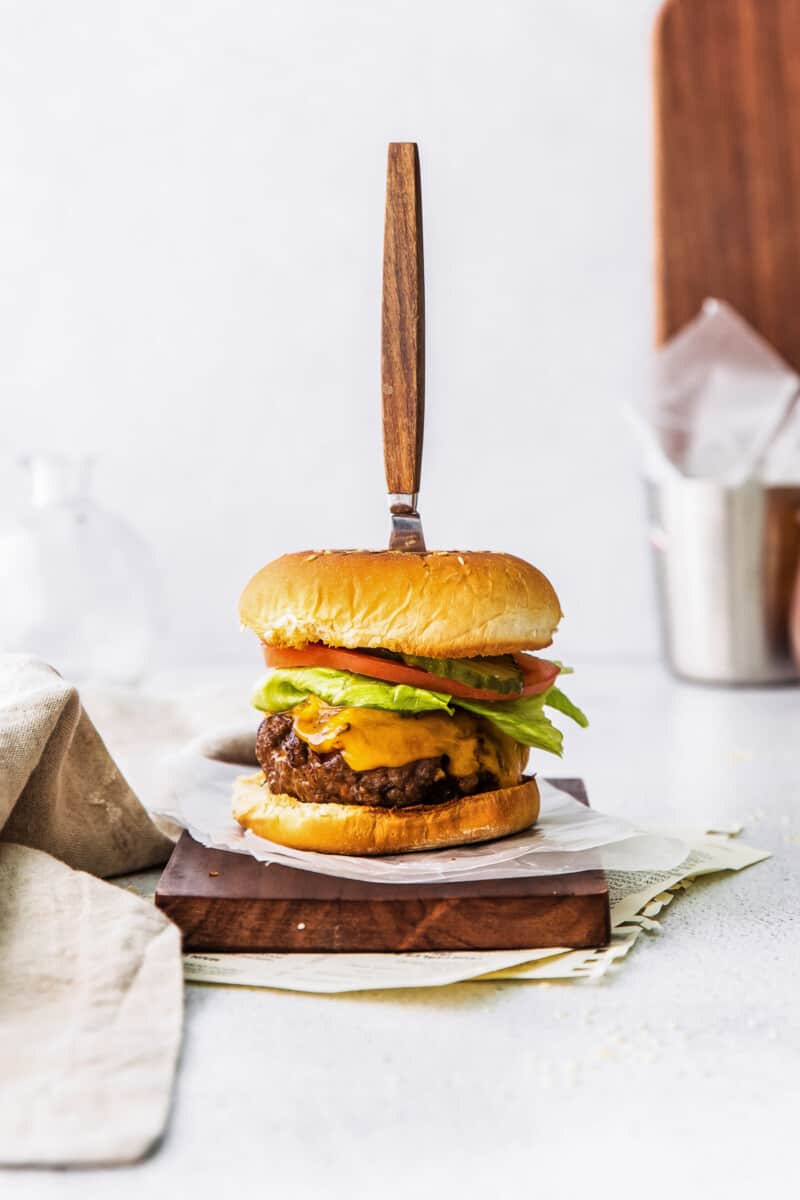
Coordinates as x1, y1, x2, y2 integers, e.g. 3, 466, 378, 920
261, 646, 559, 702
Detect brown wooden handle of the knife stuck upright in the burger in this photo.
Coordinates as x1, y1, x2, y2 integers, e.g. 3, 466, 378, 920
381, 142, 425, 496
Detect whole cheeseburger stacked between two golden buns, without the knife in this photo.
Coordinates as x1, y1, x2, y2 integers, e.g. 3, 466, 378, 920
234, 551, 587, 854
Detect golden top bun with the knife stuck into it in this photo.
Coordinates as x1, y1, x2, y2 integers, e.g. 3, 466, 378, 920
239, 550, 561, 658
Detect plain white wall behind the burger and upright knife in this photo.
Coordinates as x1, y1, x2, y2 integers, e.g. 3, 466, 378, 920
0, 0, 657, 664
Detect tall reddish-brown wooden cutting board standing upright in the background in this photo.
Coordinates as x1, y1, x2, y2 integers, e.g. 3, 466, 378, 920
654, 0, 800, 367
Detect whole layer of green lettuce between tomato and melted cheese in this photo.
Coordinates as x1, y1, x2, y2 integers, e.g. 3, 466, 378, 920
252, 667, 589, 755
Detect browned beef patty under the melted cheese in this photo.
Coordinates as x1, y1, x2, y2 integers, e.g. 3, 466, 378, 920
255, 713, 498, 808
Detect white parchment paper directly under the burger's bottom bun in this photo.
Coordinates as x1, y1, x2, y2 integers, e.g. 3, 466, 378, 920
155, 743, 687, 883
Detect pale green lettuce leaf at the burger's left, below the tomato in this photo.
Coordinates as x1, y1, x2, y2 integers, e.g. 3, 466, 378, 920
252, 667, 452, 715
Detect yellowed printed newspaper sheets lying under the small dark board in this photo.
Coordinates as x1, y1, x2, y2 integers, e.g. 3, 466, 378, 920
184, 829, 769, 994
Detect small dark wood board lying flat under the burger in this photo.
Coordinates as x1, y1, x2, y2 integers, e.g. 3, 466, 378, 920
156, 779, 610, 953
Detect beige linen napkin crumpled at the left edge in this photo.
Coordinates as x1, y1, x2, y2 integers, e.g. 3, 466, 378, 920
0, 654, 182, 1165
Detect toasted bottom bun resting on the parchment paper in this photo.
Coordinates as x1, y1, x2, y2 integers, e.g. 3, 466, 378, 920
233, 772, 539, 854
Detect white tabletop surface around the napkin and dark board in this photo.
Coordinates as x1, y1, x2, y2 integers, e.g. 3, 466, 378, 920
7, 661, 800, 1200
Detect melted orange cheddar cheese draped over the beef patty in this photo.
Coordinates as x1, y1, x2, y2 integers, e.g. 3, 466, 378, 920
291, 696, 528, 787
